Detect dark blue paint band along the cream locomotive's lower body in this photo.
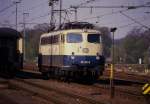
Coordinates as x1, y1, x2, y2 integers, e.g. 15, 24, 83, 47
41, 55, 105, 67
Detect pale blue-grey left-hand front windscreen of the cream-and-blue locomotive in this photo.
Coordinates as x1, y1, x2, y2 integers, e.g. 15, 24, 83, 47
67, 33, 82, 43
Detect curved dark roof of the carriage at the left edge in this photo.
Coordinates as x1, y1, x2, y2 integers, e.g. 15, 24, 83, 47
0, 28, 21, 38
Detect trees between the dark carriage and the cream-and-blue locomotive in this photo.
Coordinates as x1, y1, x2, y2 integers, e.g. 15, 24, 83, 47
22, 23, 49, 62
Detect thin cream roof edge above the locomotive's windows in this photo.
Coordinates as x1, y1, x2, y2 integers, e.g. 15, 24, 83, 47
41, 29, 100, 37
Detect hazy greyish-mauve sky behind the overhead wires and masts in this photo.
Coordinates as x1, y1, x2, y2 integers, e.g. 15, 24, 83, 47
0, 0, 150, 39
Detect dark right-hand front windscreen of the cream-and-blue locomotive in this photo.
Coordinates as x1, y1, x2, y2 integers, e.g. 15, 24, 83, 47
87, 34, 102, 43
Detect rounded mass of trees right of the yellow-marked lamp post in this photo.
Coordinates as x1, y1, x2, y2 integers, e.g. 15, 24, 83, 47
115, 28, 150, 64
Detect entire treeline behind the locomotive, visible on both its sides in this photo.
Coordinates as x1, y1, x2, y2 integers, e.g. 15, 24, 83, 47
22, 23, 150, 64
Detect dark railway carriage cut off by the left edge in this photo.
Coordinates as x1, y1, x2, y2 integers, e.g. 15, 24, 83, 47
0, 28, 23, 76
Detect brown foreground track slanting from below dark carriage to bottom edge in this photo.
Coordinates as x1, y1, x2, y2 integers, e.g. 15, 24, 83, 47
9, 79, 107, 104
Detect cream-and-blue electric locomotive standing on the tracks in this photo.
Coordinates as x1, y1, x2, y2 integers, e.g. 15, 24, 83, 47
38, 29, 105, 79
